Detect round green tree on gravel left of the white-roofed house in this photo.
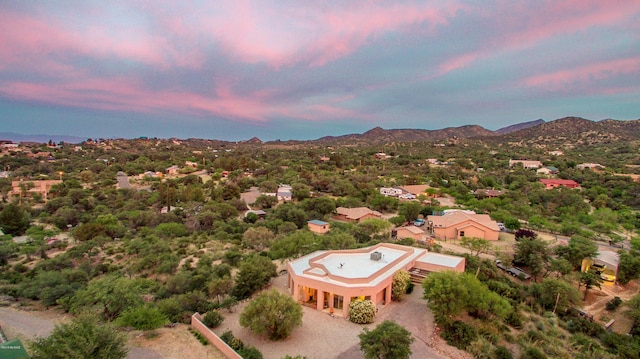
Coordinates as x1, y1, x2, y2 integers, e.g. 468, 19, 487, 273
240, 289, 302, 340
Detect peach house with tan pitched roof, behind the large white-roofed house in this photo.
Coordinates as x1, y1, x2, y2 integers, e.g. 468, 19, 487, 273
427, 211, 500, 241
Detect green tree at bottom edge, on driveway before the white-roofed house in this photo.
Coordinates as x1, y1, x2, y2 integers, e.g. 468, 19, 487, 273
358, 320, 415, 359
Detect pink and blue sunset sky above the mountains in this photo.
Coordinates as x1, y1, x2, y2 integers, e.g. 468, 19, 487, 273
0, 0, 640, 141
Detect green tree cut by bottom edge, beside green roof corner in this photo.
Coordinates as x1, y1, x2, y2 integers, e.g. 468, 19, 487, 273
31, 317, 127, 359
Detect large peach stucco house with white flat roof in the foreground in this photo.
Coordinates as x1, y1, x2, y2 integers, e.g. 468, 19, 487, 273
287, 243, 465, 317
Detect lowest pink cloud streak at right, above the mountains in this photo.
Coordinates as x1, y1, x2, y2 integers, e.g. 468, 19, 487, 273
522, 57, 640, 90
